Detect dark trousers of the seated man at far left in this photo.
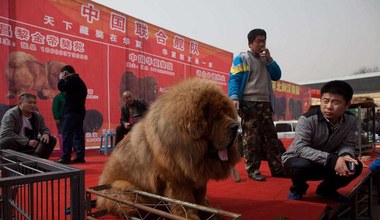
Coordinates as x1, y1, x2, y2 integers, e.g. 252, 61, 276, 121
0, 136, 57, 159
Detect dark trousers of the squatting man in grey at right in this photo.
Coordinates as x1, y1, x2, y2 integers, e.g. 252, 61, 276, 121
284, 157, 363, 194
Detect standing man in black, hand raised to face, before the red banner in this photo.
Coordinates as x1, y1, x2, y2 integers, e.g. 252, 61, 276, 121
58, 65, 87, 164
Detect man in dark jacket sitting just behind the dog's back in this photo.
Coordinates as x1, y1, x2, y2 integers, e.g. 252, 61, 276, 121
115, 91, 148, 145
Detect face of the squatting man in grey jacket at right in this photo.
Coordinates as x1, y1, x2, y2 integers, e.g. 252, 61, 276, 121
321, 93, 350, 123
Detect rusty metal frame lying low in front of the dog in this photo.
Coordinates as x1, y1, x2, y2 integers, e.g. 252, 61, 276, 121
86, 185, 243, 220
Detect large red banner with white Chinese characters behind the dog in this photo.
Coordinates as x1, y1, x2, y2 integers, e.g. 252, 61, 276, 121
0, 0, 232, 146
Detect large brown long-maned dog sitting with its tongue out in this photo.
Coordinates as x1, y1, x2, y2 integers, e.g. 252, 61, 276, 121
97, 78, 240, 219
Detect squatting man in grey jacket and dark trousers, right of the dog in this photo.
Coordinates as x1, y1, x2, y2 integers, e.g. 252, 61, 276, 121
282, 81, 363, 202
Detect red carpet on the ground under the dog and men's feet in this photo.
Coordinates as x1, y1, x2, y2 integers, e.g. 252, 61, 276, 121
51, 147, 368, 220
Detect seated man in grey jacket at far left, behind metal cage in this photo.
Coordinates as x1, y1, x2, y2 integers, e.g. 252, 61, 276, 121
0, 93, 57, 159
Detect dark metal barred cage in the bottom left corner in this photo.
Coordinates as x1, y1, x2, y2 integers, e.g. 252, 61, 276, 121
0, 150, 86, 220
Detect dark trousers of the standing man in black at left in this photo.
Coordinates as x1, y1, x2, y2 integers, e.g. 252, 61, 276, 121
62, 112, 85, 160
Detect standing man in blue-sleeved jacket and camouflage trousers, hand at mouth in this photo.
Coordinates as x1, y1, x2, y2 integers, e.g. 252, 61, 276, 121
228, 29, 285, 181
